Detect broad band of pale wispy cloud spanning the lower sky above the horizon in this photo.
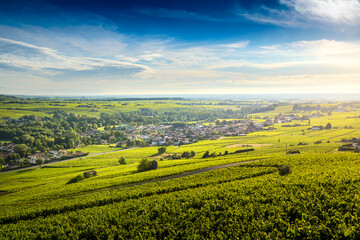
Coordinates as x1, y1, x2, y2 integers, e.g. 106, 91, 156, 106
0, 24, 360, 94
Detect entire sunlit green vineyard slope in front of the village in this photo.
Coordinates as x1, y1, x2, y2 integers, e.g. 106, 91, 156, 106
0, 104, 360, 239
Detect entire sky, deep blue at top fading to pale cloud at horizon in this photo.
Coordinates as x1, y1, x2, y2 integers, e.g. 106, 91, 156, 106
0, 0, 360, 96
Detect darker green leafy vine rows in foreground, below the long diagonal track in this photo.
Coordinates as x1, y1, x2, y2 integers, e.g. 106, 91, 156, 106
0, 154, 360, 239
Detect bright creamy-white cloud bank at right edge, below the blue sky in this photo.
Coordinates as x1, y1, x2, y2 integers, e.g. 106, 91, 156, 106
209, 39, 360, 73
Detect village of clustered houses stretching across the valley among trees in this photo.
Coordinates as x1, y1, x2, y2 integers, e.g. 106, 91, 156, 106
0, 114, 317, 169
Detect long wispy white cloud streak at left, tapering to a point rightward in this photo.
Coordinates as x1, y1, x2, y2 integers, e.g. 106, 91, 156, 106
0, 38, 150, 77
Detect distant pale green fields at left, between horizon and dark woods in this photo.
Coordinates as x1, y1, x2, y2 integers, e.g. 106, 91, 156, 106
0, 100, 256, 119
